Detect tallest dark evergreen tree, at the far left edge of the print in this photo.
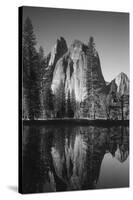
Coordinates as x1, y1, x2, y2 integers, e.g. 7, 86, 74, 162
23, 17, 40, 119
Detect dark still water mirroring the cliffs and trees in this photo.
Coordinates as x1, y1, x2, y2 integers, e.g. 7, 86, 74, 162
22, 125, 129, 193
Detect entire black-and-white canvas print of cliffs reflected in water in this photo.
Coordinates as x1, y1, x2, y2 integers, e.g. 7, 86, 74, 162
19, 6, 130, 194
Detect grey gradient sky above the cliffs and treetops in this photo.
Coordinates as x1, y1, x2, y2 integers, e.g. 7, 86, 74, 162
23, 7, 129, 81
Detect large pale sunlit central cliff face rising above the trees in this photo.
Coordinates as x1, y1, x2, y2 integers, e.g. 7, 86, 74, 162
51, 40, 105, 102
